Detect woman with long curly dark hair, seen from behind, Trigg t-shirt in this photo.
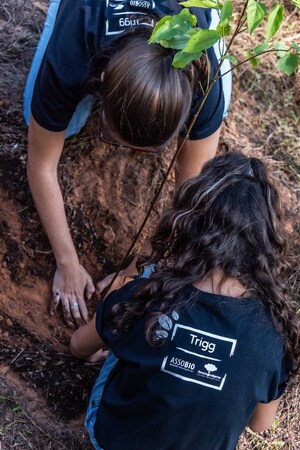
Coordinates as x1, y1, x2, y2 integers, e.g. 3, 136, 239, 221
71, 153, 300, 450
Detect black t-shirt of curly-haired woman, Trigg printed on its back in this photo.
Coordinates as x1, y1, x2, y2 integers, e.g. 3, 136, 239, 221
94, 280, 289, 450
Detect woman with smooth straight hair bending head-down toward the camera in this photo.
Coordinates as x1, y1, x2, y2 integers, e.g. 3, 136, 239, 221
24, 0, 231, 325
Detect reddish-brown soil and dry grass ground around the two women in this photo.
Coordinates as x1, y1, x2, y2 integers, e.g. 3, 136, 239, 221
0, 0, 300, 450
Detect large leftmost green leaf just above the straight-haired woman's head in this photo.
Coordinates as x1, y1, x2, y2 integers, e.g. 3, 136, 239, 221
148, 8, 197, 50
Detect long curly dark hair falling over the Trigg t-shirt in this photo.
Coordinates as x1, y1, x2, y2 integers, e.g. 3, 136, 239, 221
112, 153, 300, 372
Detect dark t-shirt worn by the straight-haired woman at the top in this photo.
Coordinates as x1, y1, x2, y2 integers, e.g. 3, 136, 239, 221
31, 0, 224, 139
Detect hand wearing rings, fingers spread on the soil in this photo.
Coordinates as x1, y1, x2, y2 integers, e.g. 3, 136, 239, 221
50, 264, 95, 327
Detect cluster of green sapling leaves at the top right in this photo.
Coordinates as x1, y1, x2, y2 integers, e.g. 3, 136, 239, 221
149, 0, 300, 75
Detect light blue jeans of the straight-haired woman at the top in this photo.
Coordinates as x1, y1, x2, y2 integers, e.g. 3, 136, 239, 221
24, 0, 232, 137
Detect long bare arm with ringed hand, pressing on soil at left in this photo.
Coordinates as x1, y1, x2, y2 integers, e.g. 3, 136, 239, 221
28, 116, 94, 325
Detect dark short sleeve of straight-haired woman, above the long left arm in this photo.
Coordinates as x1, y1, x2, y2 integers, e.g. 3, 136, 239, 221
31, 0, 92, 131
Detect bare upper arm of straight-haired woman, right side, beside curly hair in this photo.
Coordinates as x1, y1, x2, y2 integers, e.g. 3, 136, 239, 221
175, 128, 221, 186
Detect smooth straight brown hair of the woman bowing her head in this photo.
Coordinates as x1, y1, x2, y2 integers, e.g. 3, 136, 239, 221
87, 26, 207, 147
